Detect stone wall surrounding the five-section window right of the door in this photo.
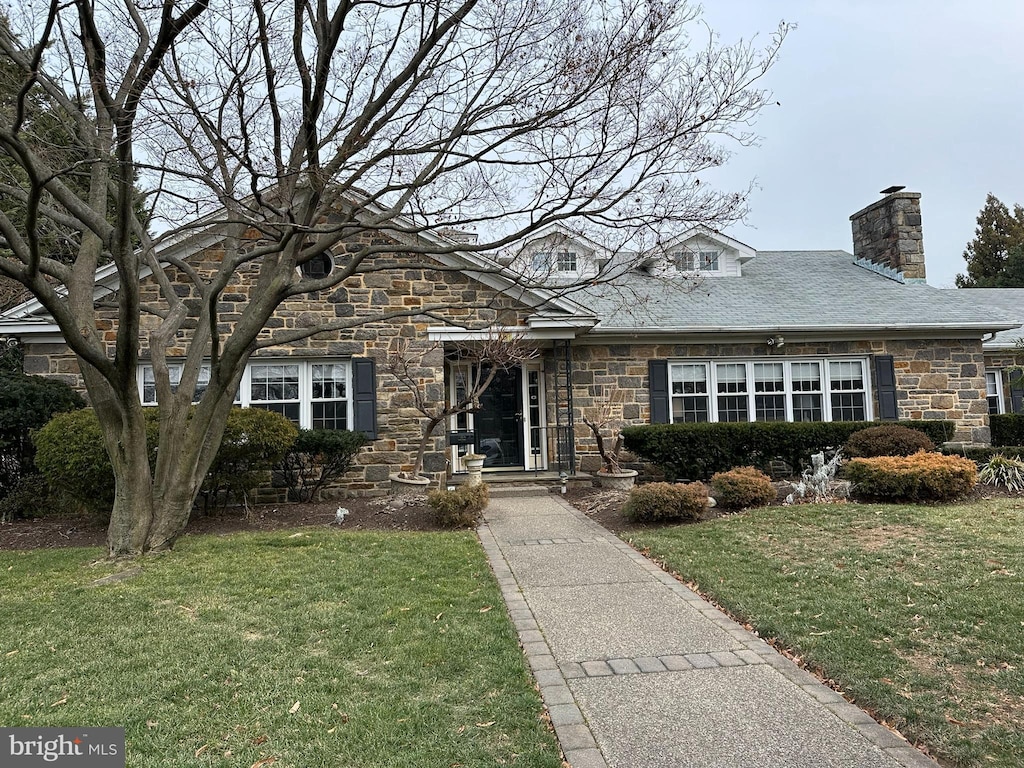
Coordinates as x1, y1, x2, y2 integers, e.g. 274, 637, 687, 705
569, 339, 990, 471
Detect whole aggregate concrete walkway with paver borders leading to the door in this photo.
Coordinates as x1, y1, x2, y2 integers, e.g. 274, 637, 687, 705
479, 495, 936, 768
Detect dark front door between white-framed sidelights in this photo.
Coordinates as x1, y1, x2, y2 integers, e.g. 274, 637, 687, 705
474, 369, 523, 467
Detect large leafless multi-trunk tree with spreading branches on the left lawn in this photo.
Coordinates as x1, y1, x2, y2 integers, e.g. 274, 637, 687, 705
0, 0, 786, 556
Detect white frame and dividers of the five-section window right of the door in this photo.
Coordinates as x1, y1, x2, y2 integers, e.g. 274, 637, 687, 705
669, 355, 874, 423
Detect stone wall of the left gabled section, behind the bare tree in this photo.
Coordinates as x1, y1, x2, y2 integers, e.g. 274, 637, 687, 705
25, 237, 528, 495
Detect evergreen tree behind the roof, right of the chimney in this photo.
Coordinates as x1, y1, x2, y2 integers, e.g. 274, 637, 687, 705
956, 193, 1024, 288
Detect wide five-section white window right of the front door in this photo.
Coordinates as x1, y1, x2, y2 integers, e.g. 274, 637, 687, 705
669, 358, 871, 424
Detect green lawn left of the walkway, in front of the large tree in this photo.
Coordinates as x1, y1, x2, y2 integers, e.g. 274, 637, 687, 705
0, 529, 560, 768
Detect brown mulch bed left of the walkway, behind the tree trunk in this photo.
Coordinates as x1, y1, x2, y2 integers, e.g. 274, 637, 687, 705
0, 497, 440, 550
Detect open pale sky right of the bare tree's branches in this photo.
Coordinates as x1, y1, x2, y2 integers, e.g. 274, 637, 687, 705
703, 0, 1024, 288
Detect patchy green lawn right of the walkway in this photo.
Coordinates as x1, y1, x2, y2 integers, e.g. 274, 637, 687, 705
629, 500, 1024, 766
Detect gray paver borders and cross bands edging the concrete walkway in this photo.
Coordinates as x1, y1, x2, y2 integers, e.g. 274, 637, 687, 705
477, 497, 938, 768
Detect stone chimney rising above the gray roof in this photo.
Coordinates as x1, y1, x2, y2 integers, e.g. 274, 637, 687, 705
850, 191, 925, 283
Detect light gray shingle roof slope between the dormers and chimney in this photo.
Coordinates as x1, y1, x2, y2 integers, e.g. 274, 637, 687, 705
571, 251, 1024, 333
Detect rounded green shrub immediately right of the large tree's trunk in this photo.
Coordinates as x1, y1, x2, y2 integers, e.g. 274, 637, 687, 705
200, 408, 298, 510
